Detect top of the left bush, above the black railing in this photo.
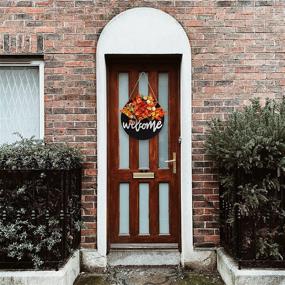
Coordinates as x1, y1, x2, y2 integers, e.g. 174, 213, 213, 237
0, 137, 82, 170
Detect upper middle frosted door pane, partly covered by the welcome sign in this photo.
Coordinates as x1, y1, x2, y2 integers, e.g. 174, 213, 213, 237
139, 73, 149, 169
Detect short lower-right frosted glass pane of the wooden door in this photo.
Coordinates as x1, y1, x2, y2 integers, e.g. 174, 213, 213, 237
159, 183, 169, 235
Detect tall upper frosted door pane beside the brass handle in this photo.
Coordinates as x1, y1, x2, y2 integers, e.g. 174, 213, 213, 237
158, 73, 168, 168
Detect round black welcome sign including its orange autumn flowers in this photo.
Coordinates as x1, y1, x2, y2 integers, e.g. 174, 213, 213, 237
121, 95, 165, 140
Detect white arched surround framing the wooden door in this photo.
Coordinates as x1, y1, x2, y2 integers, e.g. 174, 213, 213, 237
96, 8, 193, 264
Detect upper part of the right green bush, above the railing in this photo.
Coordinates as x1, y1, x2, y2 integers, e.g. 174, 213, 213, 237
206, 99, 285, 173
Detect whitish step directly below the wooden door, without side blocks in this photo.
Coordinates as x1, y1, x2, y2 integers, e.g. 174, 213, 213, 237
107, 248, 181, 266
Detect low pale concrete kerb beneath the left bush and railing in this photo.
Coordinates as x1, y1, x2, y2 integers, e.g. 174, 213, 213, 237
0, 250, 80, 285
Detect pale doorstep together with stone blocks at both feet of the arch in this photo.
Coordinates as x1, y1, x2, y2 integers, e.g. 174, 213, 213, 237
81, 244, 217, 272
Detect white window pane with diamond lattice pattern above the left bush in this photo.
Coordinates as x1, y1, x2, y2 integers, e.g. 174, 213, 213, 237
0, 66, 40, 144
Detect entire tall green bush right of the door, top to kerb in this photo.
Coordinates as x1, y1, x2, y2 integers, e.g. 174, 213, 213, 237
206, 98, 285, 259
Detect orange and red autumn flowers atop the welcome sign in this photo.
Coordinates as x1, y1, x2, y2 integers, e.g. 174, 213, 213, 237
121, 95, 165, 121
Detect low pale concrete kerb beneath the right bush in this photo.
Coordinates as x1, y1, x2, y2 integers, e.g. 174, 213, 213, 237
217, 248, 285, 285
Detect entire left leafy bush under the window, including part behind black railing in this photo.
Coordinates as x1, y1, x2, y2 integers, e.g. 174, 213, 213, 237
0, 135, 82, 269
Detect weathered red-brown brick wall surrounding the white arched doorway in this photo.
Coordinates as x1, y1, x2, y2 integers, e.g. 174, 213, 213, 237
0, 0, 285, 248
